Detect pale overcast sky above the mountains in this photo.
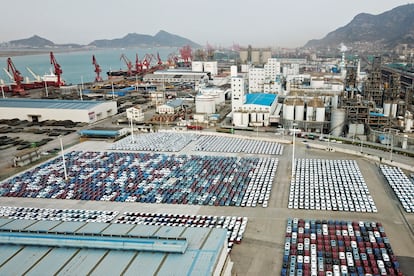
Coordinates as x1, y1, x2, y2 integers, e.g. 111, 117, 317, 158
0, 0, 409, 47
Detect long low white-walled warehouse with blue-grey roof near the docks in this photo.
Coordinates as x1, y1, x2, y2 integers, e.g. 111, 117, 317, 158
0, 99, 118, 123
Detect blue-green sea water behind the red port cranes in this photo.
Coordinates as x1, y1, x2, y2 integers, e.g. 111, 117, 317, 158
0, 47, 179, 84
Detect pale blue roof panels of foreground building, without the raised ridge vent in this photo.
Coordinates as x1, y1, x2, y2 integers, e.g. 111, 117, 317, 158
0, 219, 226, 275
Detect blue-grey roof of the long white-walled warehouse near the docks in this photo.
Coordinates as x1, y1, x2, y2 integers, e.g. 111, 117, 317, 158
0, 99, 103, 110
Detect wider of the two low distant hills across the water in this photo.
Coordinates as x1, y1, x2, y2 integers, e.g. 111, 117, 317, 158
88, 30, 200, 48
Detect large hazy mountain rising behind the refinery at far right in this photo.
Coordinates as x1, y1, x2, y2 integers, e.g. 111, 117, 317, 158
304, 4, 414, 48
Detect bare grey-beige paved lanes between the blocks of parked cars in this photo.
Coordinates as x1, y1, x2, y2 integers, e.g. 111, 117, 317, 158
0, 135, 414, 275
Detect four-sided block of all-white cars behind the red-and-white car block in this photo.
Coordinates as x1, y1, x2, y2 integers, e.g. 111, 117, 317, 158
288, 159, 377, 212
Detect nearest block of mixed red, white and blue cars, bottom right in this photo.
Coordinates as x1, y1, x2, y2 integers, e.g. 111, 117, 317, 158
281, 218, 402, 276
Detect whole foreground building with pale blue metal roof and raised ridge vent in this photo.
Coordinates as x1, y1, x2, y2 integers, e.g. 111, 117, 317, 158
0, 218, 232, 275
